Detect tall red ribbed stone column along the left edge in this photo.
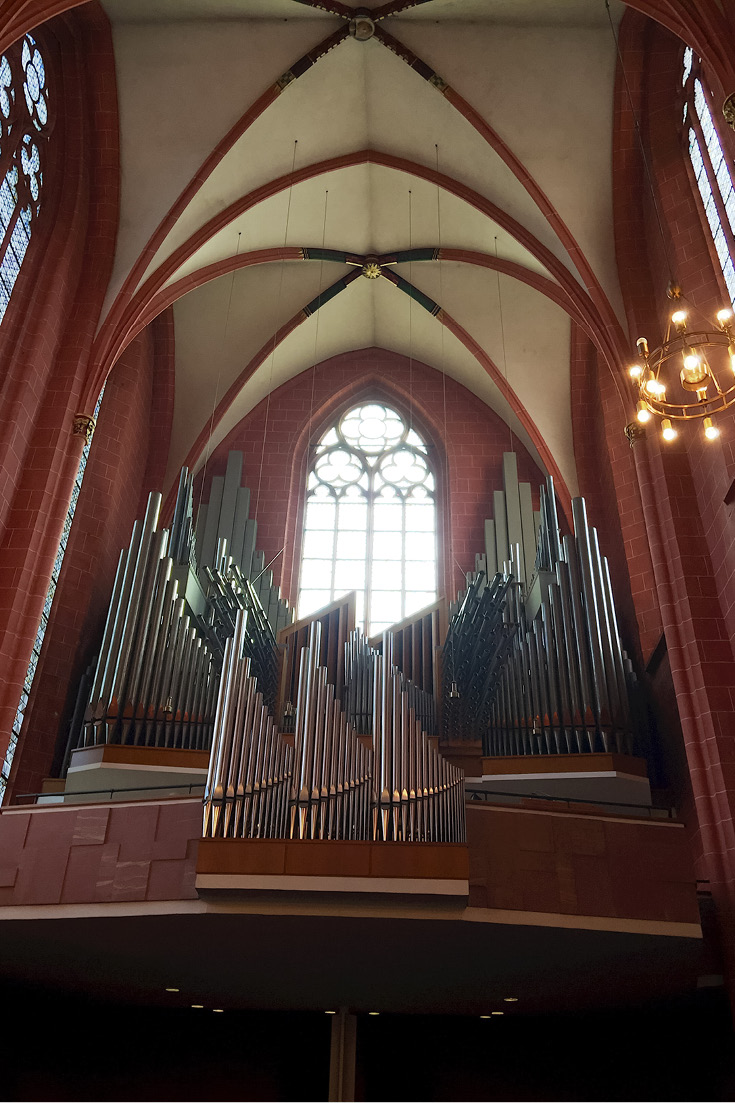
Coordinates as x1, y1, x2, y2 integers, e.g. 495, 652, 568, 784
0, 6, 118, 785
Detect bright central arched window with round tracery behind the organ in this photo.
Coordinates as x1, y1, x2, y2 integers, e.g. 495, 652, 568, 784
298, 403, 437, 635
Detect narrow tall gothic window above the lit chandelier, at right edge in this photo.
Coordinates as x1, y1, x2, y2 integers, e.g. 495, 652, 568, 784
682, 46, 735, 304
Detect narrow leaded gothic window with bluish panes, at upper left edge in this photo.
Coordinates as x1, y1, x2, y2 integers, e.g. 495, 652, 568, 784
0, 34, 50, 321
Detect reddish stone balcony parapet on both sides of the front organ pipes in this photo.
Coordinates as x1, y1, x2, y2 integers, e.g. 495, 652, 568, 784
0, 800, 699, 923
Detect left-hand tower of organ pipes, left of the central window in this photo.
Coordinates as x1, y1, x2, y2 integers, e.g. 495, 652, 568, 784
72, 452, 292, 762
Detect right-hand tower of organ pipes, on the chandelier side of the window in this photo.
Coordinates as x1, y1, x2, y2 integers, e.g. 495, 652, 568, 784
443, 479, 636, 756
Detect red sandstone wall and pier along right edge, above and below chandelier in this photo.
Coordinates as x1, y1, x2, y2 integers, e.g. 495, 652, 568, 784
616, 11, 735, 995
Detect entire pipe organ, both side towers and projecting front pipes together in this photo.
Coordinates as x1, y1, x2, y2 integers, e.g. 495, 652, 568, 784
54, 452, 650, 851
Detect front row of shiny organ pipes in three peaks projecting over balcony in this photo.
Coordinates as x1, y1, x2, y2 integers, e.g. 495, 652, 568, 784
204, 611, 465, 842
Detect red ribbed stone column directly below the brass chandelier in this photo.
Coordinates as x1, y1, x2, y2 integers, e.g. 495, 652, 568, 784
633, 435, 735, 1006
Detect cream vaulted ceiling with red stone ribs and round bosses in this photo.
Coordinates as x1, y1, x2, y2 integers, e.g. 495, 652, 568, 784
98, 0, 624, 493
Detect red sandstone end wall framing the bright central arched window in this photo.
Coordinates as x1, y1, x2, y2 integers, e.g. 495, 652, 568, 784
196, 349, 544, 597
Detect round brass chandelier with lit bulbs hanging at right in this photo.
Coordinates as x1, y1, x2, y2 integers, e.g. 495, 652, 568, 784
628, 282, 735, 441
